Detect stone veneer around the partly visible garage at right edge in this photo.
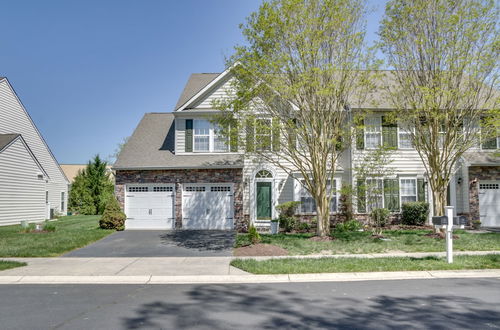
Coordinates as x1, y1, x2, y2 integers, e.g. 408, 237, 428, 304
469, 166, 500, 221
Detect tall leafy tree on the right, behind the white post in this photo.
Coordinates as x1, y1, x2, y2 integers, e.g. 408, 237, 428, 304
380, 0, 500, 215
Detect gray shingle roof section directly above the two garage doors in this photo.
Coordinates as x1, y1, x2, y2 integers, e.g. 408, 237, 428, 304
113, 113, 243, 169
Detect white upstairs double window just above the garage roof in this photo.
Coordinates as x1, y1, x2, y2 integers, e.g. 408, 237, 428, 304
193, 119, 229, 152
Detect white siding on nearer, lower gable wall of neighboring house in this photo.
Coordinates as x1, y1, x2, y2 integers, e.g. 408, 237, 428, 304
0, 138, 47, 225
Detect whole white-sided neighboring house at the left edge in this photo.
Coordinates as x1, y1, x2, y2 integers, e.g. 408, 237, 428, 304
0, 77, 69, 225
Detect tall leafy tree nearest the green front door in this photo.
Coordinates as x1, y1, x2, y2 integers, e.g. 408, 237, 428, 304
215, 0, 376, 236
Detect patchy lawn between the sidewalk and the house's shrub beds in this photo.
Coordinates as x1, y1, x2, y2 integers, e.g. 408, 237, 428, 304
236, 230, 500, 255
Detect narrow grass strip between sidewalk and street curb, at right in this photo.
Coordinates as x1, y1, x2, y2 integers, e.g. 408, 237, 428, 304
231, 254, 500, 274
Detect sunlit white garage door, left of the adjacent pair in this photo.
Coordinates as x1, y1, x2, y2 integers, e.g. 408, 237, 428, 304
125, 185, 174, 229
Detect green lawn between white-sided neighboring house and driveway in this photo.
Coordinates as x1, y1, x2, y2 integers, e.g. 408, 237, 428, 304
0, 215, 113, 257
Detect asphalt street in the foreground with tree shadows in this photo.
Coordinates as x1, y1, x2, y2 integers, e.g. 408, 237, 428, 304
0, 279, 500, 330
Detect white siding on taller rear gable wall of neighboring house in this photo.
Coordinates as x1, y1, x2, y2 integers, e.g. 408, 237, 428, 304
0, 80, 69, 217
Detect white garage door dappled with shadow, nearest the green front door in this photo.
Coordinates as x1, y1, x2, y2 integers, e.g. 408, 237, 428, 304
182, 184, 234, 229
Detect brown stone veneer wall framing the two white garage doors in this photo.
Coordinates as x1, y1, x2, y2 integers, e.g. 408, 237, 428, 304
115, 169, 248, 231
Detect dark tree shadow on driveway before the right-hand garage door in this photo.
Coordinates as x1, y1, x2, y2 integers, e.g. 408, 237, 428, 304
160, 230, 236, 251
